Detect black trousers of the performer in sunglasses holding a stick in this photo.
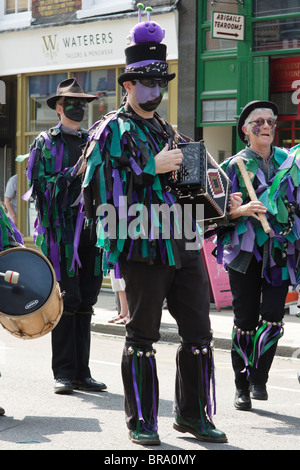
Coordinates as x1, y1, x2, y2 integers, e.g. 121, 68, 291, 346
228, 257, 289, 389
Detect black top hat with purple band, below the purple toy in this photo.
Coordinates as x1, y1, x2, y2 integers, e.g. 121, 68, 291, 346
118, 42, 176, 85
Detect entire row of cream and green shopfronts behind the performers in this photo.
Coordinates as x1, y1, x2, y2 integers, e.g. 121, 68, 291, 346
0, 0, 300, 241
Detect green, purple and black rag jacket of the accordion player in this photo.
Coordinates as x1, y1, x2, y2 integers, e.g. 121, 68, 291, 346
83, 106, 199, 278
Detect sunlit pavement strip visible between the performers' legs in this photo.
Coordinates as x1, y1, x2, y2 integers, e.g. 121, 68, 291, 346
92, 288, 300, 359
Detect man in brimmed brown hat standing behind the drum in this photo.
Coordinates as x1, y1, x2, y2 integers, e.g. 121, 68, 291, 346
28, 78, 106, 394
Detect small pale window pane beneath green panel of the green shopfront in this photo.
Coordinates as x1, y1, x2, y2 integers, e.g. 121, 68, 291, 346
202, 99, 236, 122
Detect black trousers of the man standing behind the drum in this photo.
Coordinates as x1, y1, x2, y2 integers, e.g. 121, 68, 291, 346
51, 230, 102, 379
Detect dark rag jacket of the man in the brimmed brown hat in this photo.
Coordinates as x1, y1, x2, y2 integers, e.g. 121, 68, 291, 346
23, 123, 88, 281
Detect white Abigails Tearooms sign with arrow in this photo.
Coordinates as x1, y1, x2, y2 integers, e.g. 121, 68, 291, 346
211, 11, 245, 41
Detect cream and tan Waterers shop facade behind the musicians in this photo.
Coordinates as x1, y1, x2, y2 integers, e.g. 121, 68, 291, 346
0, 0, 178, 241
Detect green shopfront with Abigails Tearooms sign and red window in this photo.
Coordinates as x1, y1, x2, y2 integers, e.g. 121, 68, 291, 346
195, 0, 300, 161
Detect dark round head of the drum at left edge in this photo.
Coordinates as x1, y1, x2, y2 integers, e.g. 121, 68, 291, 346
0, 248, 54, 316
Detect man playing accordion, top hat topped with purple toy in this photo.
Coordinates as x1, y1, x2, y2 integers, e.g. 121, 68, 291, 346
83, 8, 227, 445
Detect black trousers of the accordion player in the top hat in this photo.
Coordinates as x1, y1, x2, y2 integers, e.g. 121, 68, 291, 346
120, 241, 212, 430
